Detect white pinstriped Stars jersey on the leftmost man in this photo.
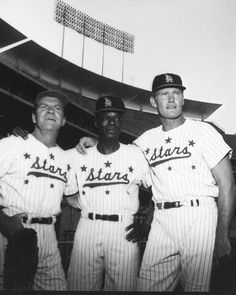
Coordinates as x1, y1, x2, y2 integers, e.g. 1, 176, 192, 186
0, 134, 77, 217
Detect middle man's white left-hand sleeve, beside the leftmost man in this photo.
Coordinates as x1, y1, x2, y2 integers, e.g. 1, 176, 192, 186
64, 149, 79, 195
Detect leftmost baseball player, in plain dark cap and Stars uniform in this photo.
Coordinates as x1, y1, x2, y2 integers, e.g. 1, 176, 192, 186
0, 91, 77, 290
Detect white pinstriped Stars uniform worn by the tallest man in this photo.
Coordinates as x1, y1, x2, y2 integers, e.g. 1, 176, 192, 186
135, 120, 231, 292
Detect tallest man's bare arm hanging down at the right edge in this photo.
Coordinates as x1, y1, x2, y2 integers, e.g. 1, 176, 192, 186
211, 155, 235, 263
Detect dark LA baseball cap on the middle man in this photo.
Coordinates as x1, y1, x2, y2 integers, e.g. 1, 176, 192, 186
95, 95, 125, 114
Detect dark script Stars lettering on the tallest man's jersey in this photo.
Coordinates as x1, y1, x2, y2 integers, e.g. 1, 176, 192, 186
149, 146, 191, 167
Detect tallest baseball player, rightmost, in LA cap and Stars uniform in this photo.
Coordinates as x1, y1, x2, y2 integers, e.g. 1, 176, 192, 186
134, 73, 235, 292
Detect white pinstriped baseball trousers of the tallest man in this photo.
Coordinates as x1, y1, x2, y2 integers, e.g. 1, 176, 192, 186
138, 201, 217, 292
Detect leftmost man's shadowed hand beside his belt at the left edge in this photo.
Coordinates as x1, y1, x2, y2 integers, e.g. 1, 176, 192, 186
1, 213, 27, 239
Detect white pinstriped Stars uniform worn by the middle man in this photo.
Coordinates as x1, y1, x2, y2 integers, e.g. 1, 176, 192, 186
68, 144, 149, 291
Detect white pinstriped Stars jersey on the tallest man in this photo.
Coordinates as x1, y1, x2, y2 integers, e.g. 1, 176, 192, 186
134, 119, 231, 201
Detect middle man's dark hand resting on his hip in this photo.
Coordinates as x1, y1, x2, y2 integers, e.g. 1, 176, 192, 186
125, 215, 151, 243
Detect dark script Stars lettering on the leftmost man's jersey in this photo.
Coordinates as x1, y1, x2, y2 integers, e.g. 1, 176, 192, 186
28, 157, 67, 182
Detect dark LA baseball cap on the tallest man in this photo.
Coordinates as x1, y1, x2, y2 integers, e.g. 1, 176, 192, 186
152, 73, 186, 92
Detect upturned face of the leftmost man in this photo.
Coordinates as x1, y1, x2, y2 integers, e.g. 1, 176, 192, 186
32, 96, 66, 130
